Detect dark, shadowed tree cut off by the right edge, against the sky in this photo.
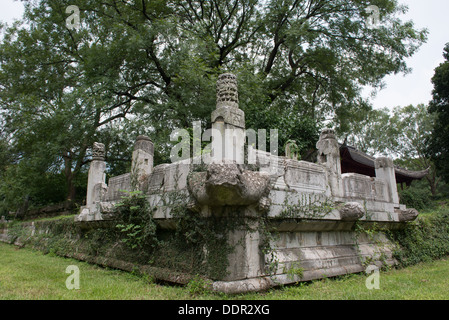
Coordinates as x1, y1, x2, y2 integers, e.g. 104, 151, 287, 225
429, 43, 449, 182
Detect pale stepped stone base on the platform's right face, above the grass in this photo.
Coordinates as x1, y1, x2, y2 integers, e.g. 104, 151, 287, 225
266, 231, 394, 283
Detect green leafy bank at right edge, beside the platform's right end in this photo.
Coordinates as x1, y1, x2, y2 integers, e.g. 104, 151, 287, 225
391, 209, 449, 266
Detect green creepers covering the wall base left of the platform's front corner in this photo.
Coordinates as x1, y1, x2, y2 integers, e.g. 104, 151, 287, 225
3, 200, 253, 282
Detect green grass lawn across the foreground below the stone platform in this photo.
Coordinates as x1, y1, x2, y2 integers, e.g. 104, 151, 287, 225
0, 243, 449, 300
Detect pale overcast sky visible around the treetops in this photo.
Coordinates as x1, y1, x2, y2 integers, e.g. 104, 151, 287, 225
0, 0, 449, 109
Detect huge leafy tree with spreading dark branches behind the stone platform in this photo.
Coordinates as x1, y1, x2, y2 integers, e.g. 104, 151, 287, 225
0, 0, 426, 209
